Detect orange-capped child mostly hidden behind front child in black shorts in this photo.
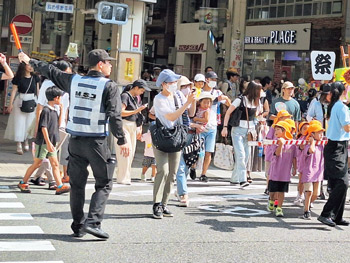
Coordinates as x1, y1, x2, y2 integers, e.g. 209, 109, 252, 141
264, 110, 292, 195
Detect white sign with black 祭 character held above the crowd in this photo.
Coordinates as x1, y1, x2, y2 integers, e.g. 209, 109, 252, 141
311, 51, 335, 80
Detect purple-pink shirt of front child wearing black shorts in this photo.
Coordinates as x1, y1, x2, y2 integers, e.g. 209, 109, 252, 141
269, 145, 297, 182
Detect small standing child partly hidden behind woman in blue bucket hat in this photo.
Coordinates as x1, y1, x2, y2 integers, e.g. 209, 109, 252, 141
141, 130, 157, 182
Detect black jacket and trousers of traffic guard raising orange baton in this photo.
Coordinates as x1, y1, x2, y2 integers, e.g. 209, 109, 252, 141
30, 59, 126, 233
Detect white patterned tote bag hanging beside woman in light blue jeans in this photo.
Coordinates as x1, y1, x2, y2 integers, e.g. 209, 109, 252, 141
214, 138, 235, 170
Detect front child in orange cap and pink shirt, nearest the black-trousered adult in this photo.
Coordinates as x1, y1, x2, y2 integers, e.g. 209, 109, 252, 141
301, 123, 325, 220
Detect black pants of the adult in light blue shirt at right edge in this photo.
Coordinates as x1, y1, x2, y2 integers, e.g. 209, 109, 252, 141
321, 140, 349, 223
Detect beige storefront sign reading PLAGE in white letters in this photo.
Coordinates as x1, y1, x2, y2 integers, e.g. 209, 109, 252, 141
244, 23, 311, 50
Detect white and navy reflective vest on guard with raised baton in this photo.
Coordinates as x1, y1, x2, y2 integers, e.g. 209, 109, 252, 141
66, 75, 110, 137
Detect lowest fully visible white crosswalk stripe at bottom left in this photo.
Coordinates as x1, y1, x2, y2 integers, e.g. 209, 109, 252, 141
0, 240, 56, 251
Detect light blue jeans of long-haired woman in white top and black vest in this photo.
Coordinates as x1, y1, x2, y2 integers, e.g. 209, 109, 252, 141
231, 127, 250, 183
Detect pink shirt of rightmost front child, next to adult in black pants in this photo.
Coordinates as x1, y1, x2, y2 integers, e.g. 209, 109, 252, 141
300, 145, 324, 183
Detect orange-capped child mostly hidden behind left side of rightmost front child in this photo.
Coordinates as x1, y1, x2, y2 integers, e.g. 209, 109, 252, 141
293, 121, 309, 206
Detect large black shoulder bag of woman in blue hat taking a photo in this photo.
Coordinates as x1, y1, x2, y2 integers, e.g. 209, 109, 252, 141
149, 97, 188, 153
